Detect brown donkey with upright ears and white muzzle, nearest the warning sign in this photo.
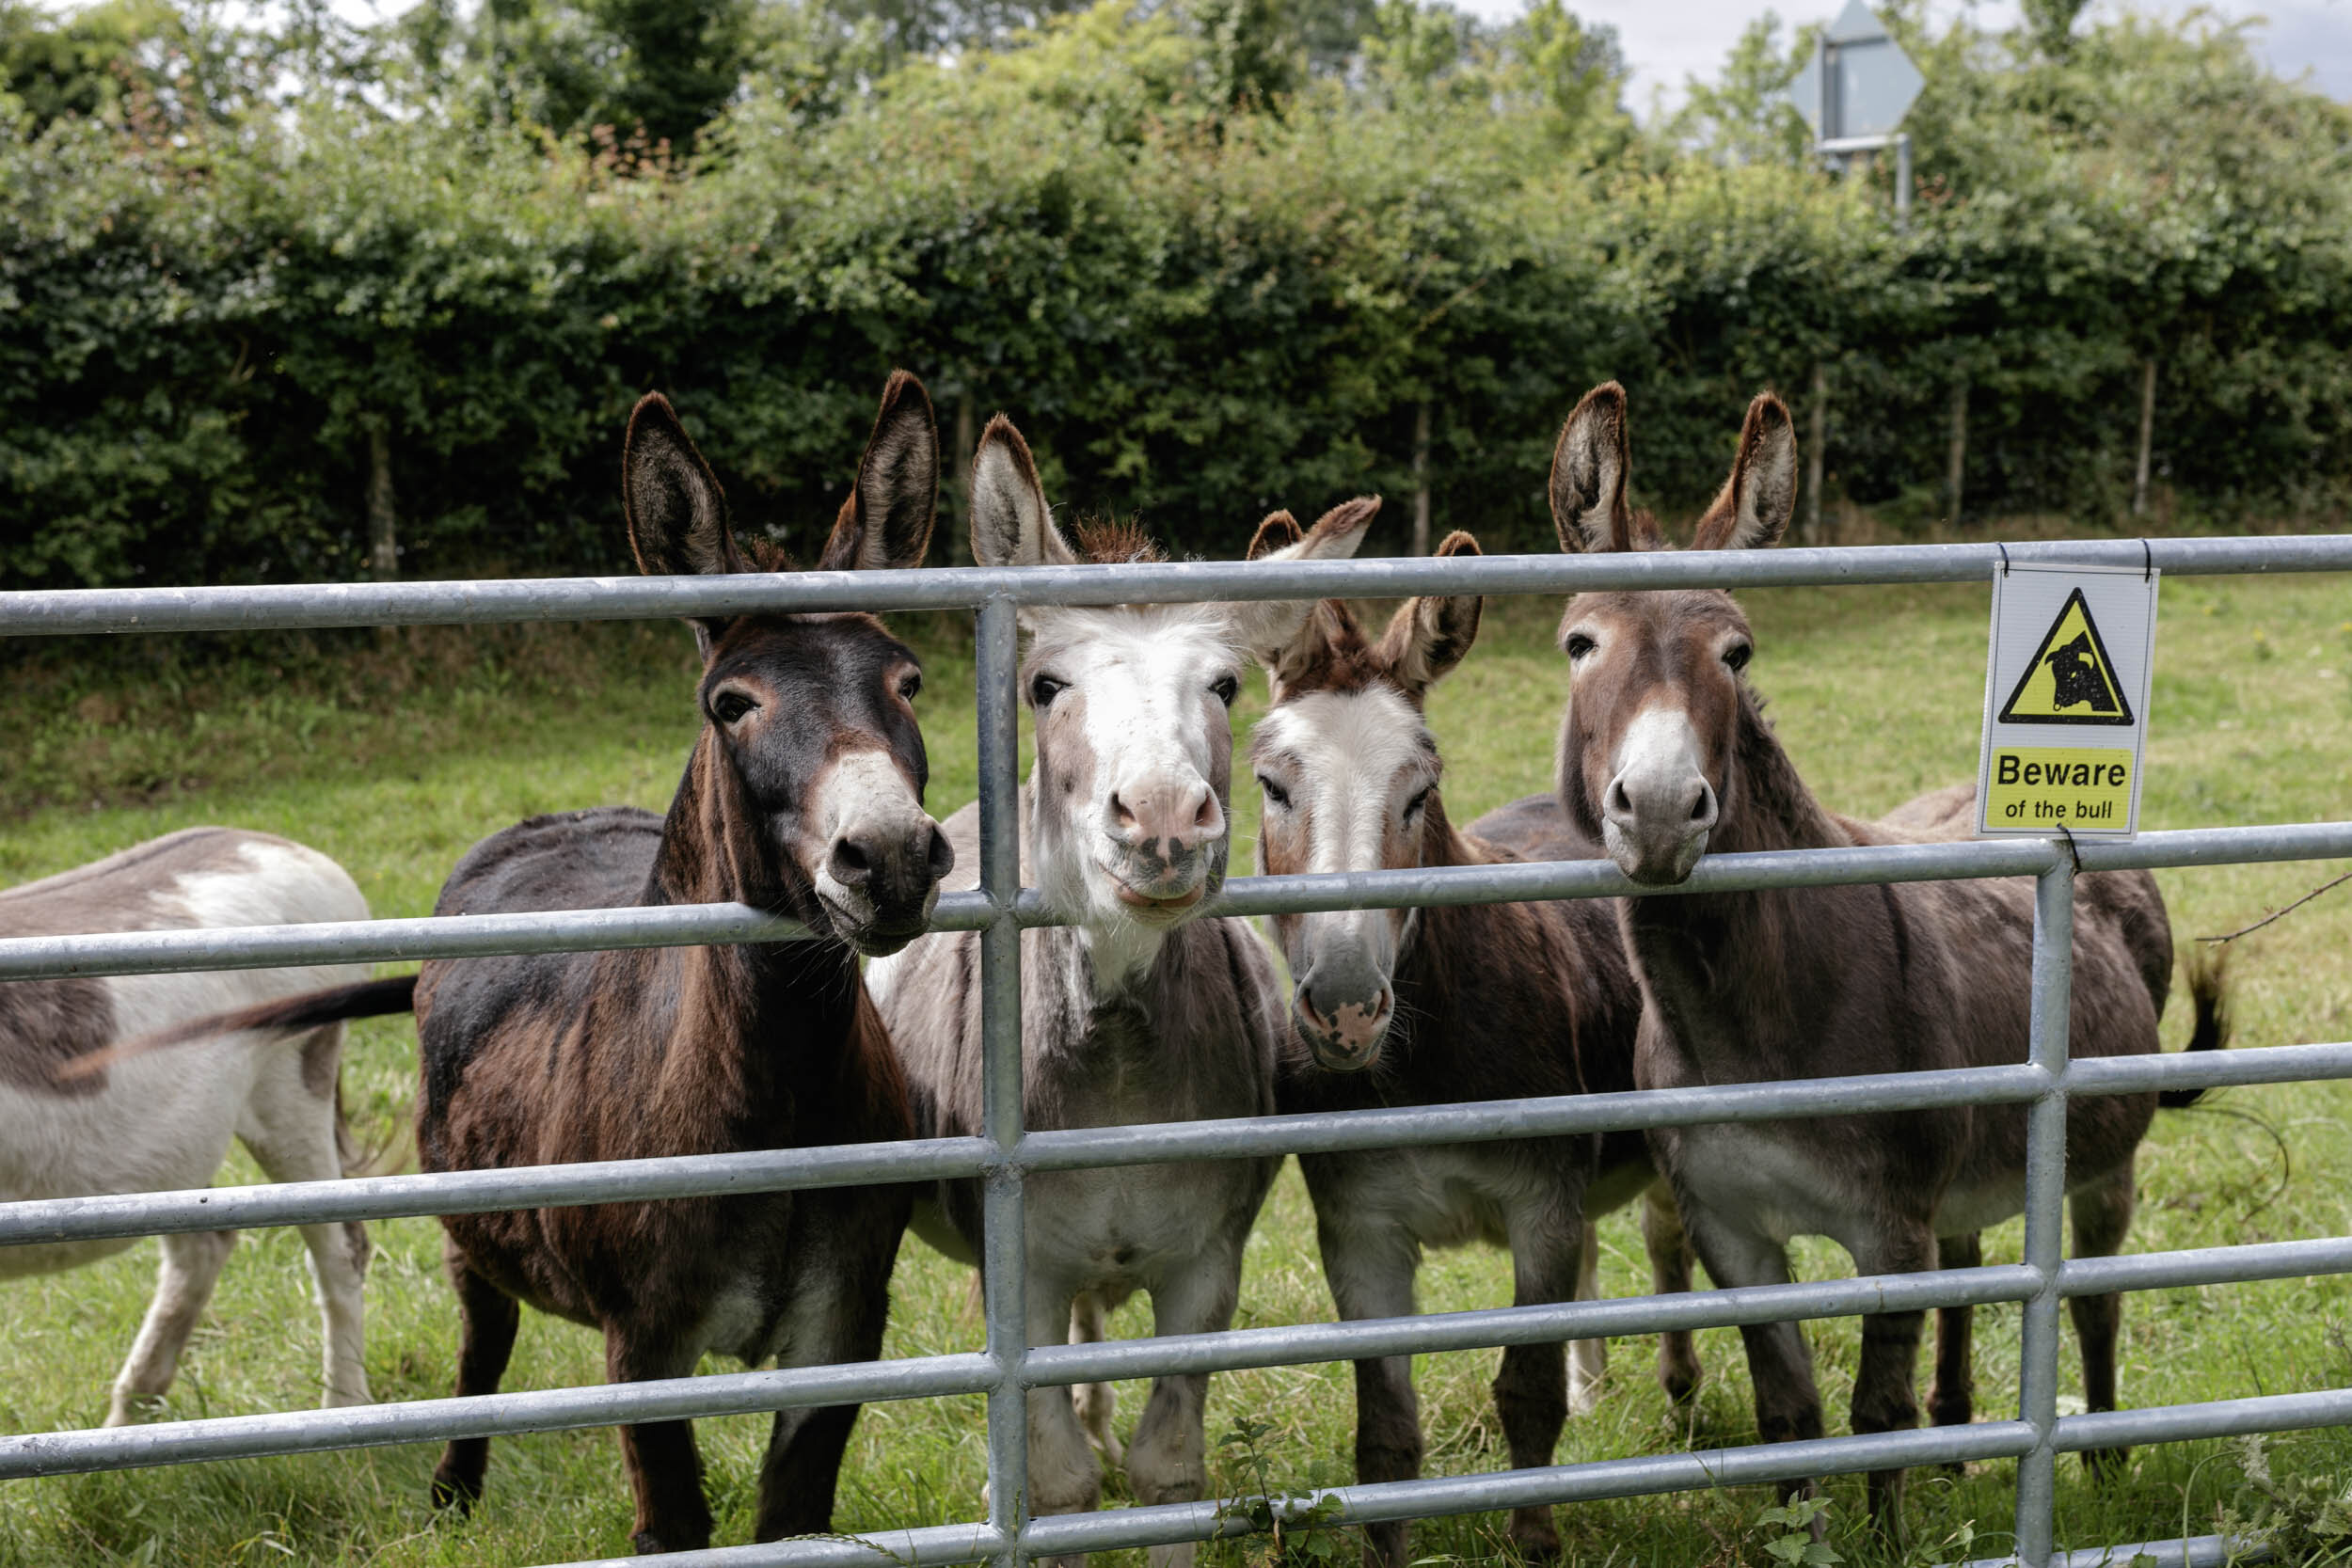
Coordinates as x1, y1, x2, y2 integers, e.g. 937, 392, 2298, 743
1550, 383, 2223, 1528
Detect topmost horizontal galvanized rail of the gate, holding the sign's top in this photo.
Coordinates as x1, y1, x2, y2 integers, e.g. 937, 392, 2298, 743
0, 533, 2352, 637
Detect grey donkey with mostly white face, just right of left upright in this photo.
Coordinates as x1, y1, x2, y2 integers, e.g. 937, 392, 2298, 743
866, 416, 1378, 1568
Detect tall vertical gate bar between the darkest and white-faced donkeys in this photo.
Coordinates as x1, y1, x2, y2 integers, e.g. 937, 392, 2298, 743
978, 599, 1028, 1568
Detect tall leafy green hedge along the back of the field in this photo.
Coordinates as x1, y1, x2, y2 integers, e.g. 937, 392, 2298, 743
0, 5, 2352, 588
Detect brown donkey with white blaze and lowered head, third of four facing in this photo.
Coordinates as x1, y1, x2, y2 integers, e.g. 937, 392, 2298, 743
1249, 513, 1698, 1568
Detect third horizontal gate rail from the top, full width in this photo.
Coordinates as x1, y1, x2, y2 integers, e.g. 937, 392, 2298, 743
13, 1044, 2352, 1246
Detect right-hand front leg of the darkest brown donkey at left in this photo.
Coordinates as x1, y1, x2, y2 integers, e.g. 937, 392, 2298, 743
753, 1190, 906, 1540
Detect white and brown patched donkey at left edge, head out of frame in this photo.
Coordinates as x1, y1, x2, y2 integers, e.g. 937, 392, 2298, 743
0, 828, 370, 1427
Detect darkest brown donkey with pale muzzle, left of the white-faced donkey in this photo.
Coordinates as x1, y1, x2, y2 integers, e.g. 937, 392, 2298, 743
179, 372, 955, 1552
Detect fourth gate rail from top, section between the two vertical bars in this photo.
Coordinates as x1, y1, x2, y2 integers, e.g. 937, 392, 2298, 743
1021, 1262, 2042, 1387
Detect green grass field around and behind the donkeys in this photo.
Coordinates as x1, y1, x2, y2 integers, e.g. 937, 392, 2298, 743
0, 566, 2352, 1568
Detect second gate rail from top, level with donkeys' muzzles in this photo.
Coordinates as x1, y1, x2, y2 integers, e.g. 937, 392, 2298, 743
0, 823, 2352, 980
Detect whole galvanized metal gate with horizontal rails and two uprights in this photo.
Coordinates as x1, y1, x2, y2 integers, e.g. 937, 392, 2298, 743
0, 536, 2352, 1568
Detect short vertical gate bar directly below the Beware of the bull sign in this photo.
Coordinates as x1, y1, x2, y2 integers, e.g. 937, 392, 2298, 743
2018, 856, 2074, 1568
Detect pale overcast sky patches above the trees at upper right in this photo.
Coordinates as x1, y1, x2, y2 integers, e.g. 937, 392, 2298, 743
1456, 0, 2352, 119
